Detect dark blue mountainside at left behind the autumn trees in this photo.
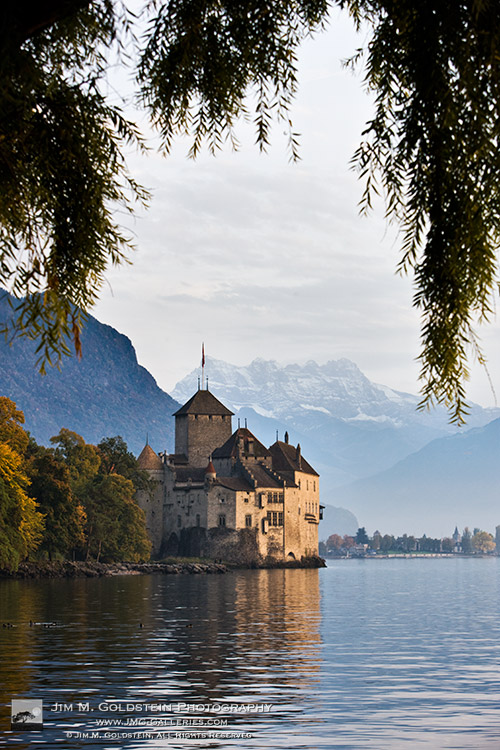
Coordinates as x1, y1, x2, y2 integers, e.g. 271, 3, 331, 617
0, 293, 179, 454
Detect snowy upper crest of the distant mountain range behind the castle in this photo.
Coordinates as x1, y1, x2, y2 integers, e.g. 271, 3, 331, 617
172, 357, 500, 432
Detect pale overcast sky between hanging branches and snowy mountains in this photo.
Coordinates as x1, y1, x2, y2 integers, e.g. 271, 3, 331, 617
93, 8, 500, 406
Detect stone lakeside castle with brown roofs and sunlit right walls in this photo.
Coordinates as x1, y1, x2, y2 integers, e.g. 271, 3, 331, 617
137, 388, 321, 560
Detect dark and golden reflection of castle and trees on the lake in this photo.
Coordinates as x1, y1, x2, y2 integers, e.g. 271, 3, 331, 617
0, 570, 320, 748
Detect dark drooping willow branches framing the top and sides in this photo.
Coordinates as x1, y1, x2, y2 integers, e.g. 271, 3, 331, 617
0, 0, 500, 422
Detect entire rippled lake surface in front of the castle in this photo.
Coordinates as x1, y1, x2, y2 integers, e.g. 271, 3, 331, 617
0, 558, 500, 750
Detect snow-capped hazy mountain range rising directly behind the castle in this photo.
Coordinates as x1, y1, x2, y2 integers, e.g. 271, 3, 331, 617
172, 357, 500, 488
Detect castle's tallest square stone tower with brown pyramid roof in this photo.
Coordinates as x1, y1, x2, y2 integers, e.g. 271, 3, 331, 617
174, 390, 233, 469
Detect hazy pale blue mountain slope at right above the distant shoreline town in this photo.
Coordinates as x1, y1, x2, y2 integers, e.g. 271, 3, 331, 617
336, 419, 500, 537
